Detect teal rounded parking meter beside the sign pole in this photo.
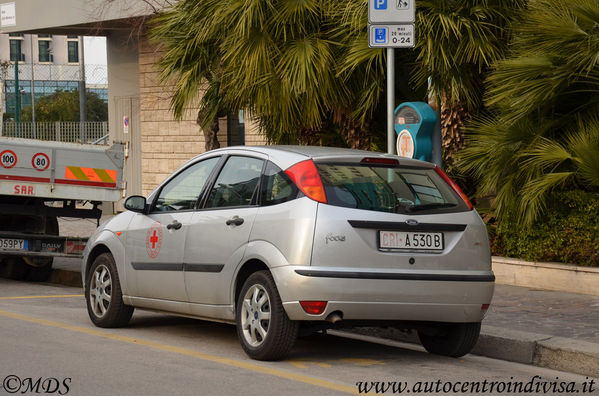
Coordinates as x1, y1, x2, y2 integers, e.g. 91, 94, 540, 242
395, 102, 437, 162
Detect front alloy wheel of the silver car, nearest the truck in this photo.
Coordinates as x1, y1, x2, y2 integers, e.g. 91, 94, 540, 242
85, 253, 134, 327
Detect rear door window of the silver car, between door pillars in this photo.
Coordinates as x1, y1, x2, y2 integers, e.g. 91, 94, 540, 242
206, 157, 264, 208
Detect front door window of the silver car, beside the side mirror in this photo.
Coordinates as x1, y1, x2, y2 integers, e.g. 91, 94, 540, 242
154, 157, 220, 212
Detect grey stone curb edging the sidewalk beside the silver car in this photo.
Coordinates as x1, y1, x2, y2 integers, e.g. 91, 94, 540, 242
48, 269, 599, 378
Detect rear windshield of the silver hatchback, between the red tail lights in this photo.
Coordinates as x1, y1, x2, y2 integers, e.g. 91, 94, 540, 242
316, 163, 468, 214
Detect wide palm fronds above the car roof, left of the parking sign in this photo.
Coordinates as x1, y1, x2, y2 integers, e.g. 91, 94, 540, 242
151, 0, 384, 148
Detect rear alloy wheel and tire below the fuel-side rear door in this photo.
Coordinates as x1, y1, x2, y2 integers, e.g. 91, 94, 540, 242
236, 271, 299, 360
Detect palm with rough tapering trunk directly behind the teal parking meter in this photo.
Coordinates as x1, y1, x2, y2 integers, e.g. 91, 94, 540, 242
414, 0, 525, 166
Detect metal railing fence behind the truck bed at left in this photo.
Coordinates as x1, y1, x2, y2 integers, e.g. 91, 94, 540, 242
2, 121, 108, 145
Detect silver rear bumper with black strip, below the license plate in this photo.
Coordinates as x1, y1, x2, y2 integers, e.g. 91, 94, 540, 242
272, 266, 495, 322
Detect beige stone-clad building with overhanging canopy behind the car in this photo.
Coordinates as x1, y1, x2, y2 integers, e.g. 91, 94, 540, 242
0, 0, 265, 195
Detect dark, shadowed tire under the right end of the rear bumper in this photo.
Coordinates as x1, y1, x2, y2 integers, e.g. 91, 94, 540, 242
418, 322, 480, 357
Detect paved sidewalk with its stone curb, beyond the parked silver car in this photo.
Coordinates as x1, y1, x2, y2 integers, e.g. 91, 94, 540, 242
52, 216, 599, 378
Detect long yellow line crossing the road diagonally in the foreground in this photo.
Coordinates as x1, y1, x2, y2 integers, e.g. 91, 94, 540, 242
0, 310, 358, 394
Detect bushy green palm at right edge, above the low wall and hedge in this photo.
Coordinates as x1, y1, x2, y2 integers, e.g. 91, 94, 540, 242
460, 0, 599, 225
